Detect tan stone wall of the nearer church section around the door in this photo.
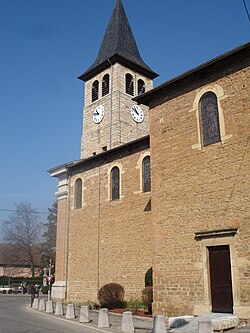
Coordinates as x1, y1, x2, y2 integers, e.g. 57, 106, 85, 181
150, 69, 250, 318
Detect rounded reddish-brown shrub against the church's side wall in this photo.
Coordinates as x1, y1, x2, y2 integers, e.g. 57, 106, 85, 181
97, 283, 124, 309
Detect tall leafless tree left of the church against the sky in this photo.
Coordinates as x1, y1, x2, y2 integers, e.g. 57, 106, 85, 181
4, 201, 41, 277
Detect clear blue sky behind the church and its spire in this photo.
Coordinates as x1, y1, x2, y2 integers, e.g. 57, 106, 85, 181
0, 0, 250, 227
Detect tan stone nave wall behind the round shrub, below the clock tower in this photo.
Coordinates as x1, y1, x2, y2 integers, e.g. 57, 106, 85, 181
65, 150, 153, 301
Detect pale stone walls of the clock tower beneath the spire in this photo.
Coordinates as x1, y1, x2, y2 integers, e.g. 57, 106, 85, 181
81, 63, 153, 158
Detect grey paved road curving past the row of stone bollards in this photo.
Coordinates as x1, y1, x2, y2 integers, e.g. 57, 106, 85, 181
0, 294, 124, 333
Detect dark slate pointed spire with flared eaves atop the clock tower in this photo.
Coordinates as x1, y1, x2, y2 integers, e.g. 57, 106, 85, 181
79, 0, 158, 81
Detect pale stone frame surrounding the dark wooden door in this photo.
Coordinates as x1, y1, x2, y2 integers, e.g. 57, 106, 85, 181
194, 235, 239, 315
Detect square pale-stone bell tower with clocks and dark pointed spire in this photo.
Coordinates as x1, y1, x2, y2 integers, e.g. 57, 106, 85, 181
79, 0, 158, 159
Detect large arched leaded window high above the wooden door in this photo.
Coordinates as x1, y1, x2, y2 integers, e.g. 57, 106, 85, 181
199, 91, 221, 146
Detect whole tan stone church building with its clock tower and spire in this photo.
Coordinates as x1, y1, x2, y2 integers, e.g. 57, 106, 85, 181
49, 0, 250, 318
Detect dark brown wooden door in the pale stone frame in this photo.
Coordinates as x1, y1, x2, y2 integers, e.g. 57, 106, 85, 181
208, 245, 233, 313
